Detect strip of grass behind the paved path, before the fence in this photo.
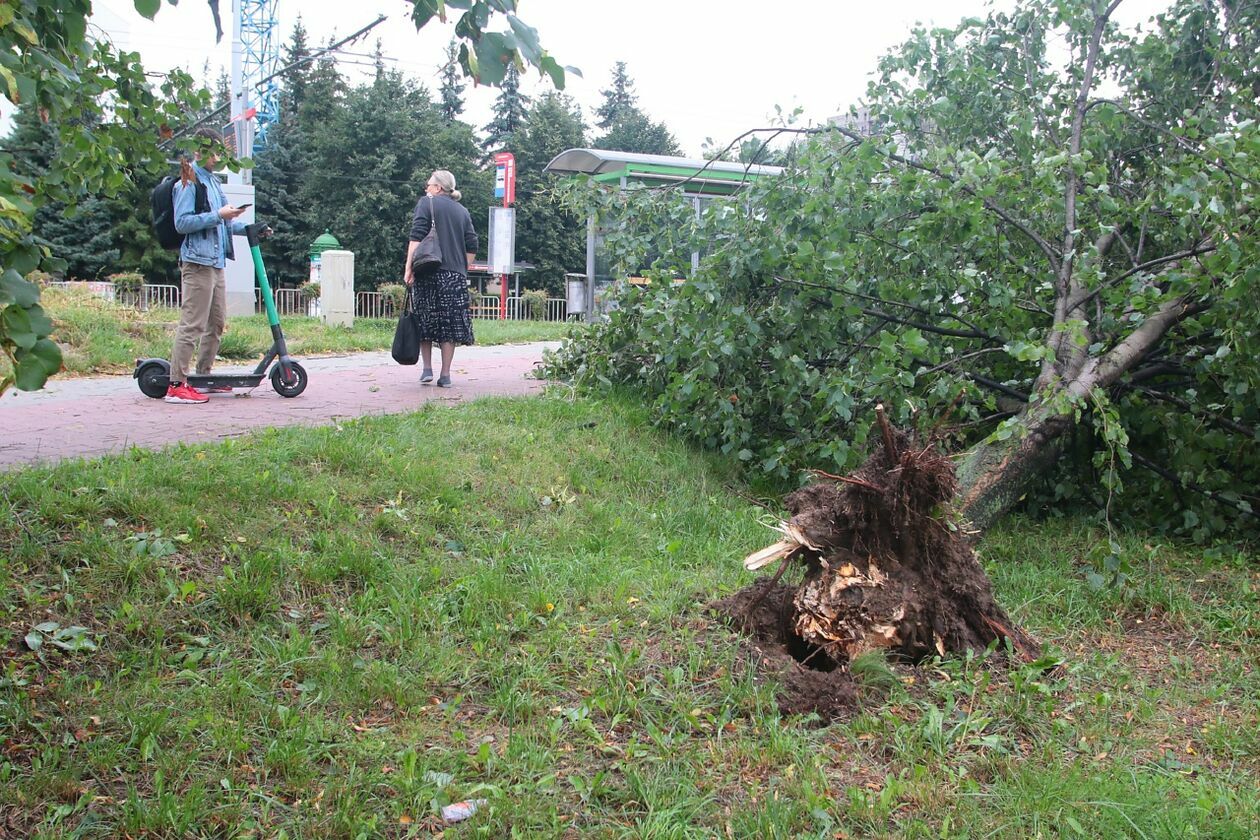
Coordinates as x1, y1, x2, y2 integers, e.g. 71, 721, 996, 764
17, 288, 572, 375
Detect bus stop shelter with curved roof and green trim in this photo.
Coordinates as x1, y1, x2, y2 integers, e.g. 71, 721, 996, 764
543, 149, 782, 319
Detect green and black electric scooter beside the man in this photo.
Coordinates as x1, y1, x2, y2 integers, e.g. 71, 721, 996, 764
131, 222, 306, 399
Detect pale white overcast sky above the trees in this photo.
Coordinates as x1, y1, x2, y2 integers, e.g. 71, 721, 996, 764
9, 0, 1168, 156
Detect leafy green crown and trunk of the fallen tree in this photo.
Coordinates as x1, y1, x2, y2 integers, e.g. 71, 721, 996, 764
553, 0, 1260, 536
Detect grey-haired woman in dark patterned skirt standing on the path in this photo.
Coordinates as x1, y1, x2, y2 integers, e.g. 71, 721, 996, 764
402, 169, 478, 388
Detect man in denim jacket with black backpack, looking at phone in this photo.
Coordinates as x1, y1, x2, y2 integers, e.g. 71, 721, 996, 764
166, 127, 247, 403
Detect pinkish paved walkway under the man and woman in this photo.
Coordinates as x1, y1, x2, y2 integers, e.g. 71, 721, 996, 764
0, 341, 558, 470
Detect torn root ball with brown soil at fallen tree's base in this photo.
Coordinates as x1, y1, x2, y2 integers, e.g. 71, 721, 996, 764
712, 411, 1040, 718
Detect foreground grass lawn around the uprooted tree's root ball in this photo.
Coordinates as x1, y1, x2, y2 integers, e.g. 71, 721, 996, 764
0, 394, 1260, 839
